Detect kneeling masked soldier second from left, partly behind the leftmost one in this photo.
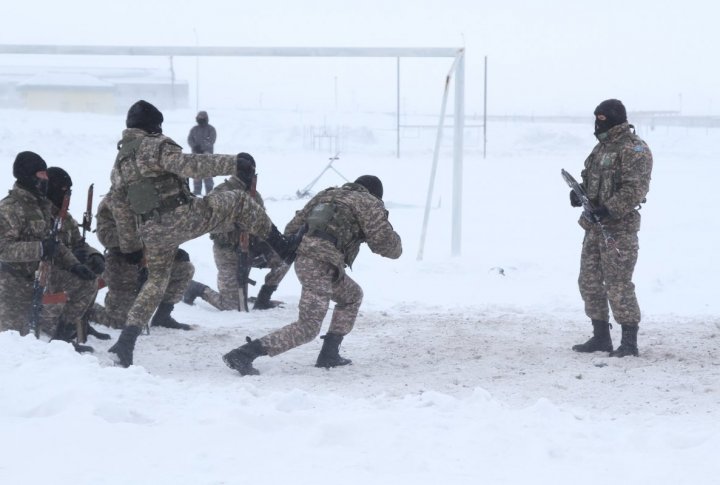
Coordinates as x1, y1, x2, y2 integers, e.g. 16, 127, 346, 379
43, 167, 110, 351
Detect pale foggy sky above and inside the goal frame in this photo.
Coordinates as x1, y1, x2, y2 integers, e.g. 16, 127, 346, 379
0, 0, 720, 115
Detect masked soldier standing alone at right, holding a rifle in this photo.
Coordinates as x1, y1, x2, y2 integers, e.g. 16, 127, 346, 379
570, 99, 653, 357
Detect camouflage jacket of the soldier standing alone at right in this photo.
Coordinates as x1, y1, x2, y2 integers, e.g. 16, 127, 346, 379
580, 123, 653, 231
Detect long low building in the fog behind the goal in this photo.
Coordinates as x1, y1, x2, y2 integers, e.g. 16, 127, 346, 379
0, 67, 188, 113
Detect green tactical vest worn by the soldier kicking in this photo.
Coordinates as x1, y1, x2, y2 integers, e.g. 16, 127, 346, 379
115, 137, 190, 220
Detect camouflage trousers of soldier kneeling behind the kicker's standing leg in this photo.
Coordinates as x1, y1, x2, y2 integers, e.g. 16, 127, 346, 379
91, 251, 195, 328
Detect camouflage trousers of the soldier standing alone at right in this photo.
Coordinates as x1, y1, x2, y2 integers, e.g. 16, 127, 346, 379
578, 226, 640, 325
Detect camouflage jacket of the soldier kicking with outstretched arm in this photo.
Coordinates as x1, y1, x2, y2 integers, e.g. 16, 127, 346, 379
110, 128, 237, 253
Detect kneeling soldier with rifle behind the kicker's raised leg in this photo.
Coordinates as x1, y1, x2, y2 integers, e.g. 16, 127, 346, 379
183, 156, 290, 311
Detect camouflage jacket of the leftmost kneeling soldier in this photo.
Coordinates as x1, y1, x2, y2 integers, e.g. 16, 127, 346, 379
0, 184, 79, 279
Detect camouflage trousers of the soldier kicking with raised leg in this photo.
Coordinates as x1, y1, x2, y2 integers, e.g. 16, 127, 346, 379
127, 190, 272, 327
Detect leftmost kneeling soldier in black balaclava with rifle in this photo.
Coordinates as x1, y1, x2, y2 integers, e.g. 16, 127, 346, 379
0, 152, 96, 351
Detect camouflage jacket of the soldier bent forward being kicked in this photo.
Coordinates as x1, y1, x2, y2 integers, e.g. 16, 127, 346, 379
285, 183, 402, 269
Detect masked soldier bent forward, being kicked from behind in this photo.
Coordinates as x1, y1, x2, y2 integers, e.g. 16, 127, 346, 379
223, 175, 402, 375
